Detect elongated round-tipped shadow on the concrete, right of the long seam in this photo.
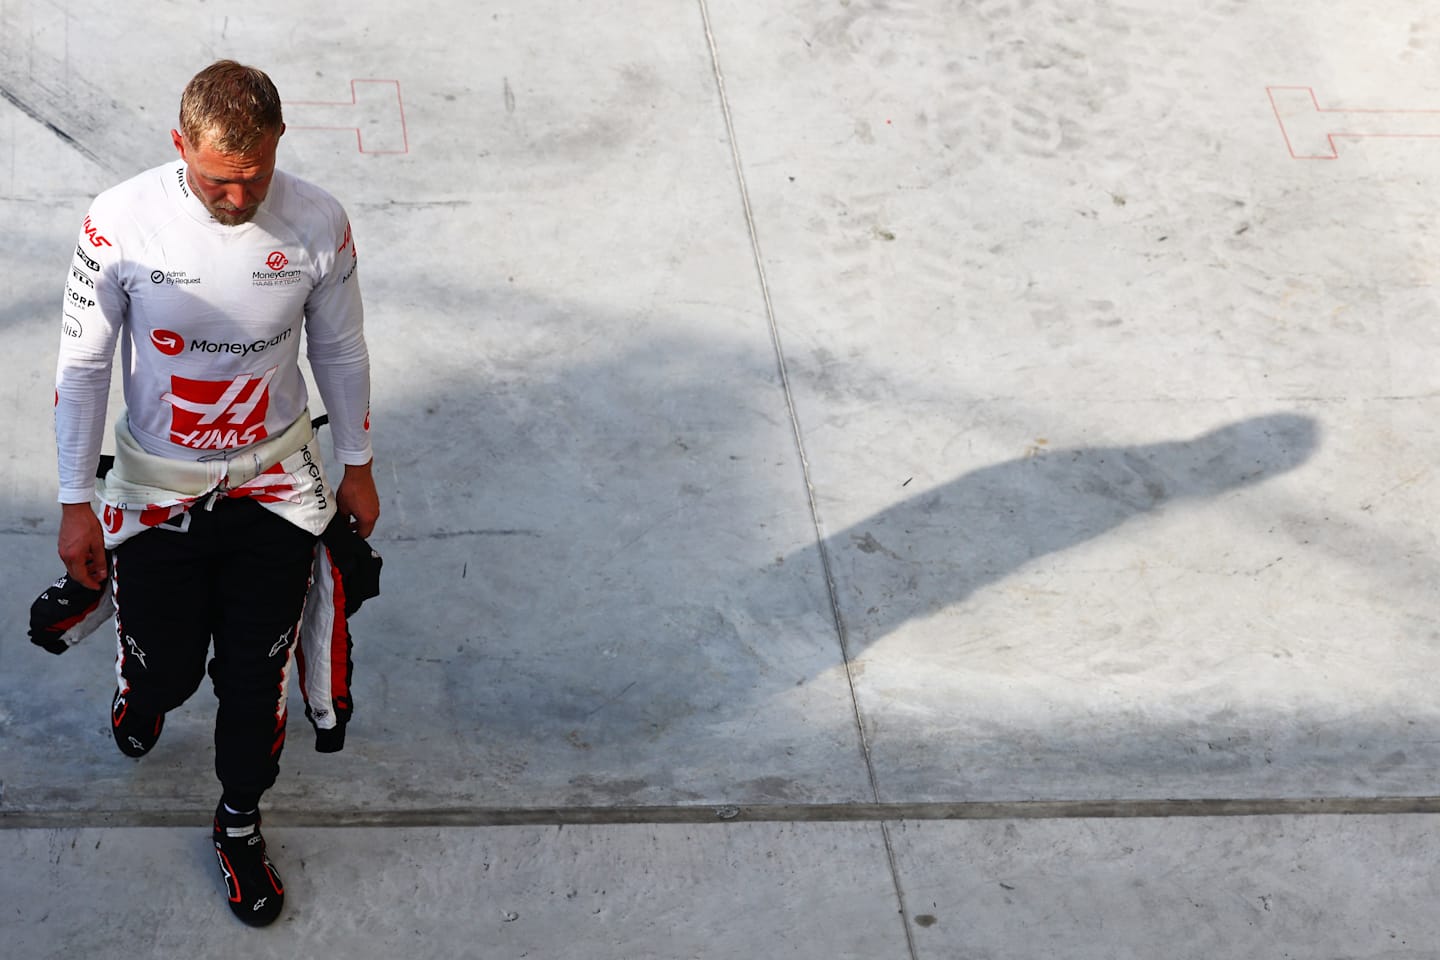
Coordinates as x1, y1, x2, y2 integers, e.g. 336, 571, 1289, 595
824, 413, 1319, 656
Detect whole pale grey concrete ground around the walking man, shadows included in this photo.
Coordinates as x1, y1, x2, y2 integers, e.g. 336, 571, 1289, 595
0, 0, 1440, 960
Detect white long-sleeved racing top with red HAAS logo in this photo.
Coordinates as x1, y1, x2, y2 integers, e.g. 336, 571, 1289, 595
55, 161, 372, 504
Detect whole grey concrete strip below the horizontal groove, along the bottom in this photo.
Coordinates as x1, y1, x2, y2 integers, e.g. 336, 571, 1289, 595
8, 816, 1440, 960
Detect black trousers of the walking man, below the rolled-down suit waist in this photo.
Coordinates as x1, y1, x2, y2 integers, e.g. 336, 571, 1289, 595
111, 497, 315, 803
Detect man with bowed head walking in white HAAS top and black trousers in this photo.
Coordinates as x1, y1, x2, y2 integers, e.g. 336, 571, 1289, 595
55, 60, 380, 925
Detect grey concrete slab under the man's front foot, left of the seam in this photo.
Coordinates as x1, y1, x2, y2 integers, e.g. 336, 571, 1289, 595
0, 823, 906, 960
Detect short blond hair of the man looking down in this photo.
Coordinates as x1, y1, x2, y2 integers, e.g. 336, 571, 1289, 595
180, 60, 285, 154
